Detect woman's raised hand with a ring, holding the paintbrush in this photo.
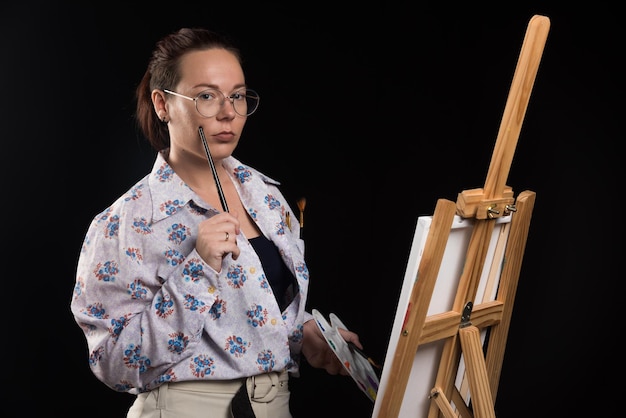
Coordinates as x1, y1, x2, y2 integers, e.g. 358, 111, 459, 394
196, 212, 240, 272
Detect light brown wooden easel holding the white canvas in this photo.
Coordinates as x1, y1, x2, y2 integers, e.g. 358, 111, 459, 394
373, 15, 550, 418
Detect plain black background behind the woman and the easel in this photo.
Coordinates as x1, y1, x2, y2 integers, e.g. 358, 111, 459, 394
0, 1, 625, 418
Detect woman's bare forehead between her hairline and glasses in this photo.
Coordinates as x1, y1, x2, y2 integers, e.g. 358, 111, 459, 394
180, 48, 244, 88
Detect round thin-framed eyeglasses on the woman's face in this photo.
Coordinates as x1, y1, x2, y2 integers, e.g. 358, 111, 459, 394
163, 89, 259, 118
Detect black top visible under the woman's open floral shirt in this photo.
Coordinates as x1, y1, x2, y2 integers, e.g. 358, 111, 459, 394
250, 235, 295, 311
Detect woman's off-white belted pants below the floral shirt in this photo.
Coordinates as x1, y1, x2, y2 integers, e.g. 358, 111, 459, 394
127, 372, 292, 418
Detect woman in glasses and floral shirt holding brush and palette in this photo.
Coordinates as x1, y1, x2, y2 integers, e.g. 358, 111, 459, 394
71, 28, 361, 418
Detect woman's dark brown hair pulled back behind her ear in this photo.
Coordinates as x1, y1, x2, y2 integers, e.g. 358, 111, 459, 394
135, 28, 241, 151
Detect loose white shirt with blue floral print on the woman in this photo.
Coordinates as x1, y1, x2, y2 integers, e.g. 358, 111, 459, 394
71, 153, 311, 394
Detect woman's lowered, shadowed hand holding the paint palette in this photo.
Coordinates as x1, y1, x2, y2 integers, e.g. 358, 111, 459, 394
302, 319, 363, 376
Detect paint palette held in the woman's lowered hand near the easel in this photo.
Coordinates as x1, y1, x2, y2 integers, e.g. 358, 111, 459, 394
312, 309, 379, 402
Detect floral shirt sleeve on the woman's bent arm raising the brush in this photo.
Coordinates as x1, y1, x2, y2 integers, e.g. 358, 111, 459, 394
71, 201, 218, 393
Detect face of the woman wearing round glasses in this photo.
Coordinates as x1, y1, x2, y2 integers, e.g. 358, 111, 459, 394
166, 49, 247, 164
